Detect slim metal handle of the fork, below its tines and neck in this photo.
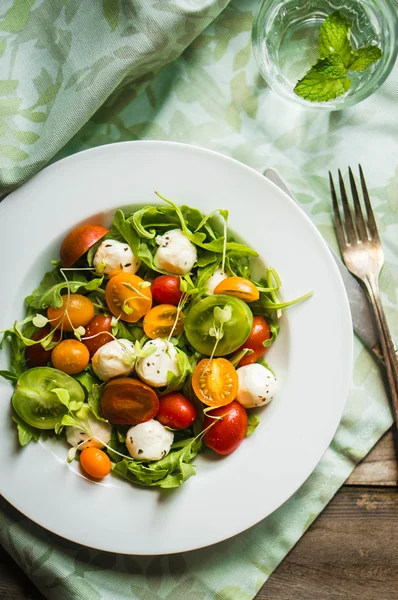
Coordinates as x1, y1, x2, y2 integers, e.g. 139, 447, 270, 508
364, 277, 398, 432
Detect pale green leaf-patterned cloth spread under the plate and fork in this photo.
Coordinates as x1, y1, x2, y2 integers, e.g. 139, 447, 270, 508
0, 0, 398, 600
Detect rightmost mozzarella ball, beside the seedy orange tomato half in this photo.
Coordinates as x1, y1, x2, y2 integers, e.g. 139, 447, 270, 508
236, 363, 277, 408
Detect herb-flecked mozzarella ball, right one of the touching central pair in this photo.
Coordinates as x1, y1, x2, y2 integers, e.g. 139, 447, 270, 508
135, 338, 180, 388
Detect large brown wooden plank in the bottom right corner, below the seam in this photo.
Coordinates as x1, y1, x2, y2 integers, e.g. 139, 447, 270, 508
257, 487, 398, 600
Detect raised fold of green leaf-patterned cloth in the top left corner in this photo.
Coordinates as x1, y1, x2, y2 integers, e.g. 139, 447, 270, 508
0, 0, 228, 194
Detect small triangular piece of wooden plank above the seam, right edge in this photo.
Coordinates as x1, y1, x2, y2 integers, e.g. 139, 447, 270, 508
346, 431, 398, 486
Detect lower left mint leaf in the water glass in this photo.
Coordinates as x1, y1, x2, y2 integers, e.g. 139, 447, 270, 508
294, 54, 351, 102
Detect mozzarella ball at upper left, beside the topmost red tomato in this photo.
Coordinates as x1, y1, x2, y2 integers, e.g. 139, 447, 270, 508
94, 240, 141, 277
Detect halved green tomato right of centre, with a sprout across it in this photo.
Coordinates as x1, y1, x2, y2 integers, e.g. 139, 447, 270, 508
184, 294, 253, 356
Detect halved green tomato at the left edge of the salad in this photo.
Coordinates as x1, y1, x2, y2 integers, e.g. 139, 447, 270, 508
12, 367, 84, 429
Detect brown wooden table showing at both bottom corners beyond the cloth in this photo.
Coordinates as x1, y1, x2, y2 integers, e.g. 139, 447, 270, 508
0, 433, 398, 600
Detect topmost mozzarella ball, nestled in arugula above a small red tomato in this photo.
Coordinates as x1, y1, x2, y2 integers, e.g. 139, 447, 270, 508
154, 229, 198, 275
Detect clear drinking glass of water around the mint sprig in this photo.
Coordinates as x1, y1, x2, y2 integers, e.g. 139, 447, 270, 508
252, 0, 398, 110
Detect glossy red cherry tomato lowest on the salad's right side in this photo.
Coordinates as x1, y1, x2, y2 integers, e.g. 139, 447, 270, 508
203, 400, 247, 454
